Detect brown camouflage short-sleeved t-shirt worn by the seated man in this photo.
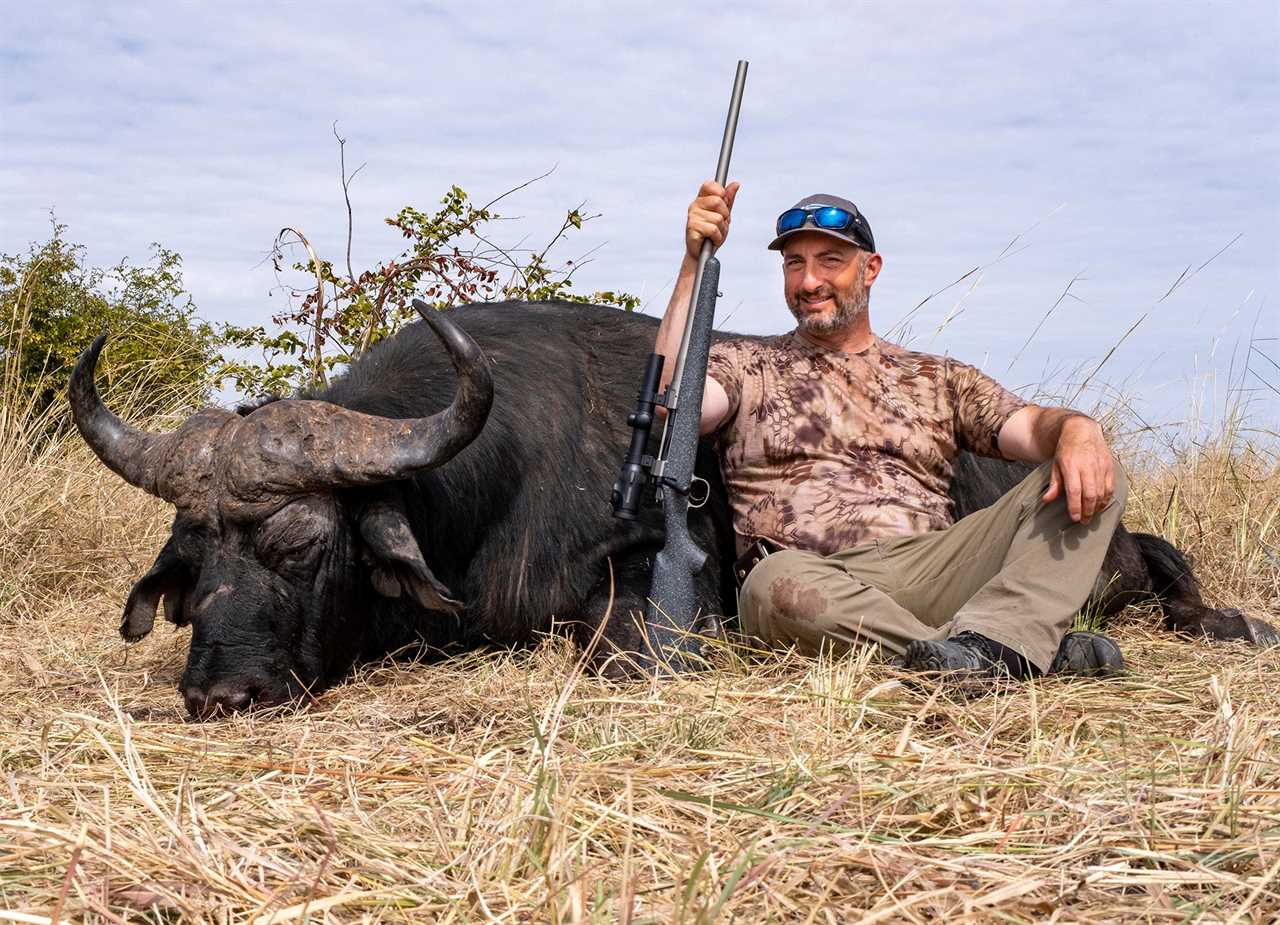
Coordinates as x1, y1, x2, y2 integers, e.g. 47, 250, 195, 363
708, 331, 1027, 555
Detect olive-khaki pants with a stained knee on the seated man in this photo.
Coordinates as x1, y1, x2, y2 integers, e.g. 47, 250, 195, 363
739, 462, 1129, 672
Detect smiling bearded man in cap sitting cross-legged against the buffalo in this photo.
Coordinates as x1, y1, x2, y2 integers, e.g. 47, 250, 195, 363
657, 182, 1126, 678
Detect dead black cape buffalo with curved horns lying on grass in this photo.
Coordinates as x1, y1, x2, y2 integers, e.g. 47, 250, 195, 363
70, 302, 1275, 716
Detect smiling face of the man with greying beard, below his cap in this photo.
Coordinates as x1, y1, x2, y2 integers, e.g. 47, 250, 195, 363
782, 232, 879, 334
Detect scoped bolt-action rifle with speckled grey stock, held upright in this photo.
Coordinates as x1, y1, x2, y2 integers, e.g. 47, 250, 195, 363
612, 61, 746, 669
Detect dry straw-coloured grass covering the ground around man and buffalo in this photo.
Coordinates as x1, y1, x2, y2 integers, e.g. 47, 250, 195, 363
0, 388, 1280, 922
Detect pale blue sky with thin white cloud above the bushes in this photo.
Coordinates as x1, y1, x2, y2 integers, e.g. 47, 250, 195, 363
0, 0, 1280, 440
